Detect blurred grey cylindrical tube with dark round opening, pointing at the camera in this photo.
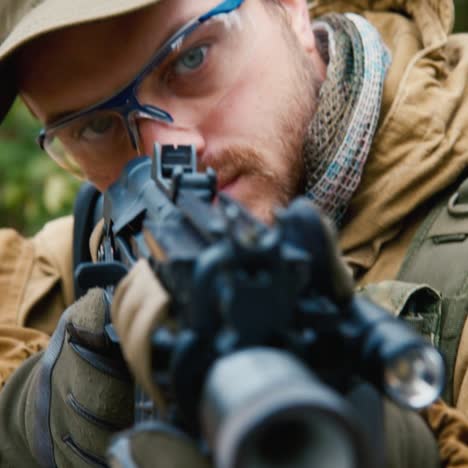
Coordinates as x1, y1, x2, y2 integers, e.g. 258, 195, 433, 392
201, 348, 370, 468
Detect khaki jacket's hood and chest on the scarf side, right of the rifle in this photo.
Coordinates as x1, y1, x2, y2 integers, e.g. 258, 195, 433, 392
311, 0, 468, 466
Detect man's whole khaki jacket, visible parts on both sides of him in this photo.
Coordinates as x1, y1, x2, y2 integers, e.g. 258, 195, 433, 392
0, 0, 468, 466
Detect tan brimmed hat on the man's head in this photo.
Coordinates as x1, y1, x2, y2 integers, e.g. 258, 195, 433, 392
0, 0, 159, 122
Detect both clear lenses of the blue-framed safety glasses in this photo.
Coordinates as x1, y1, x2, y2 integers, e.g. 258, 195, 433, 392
44, 3, 255, 182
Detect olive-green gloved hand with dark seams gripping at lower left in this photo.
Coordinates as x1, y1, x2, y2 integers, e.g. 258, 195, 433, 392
0, 289, 134, 468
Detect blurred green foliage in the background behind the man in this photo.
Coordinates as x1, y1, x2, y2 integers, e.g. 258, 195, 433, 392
0, 4, 468, 234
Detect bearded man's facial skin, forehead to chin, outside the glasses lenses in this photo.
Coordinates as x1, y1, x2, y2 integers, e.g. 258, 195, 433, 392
17, 0, 326, 221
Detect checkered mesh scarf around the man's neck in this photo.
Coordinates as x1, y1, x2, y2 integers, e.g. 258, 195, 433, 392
304, 14, 390, 226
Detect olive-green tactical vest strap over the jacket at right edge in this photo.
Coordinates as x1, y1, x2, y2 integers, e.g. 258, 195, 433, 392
398, 179, 468, 404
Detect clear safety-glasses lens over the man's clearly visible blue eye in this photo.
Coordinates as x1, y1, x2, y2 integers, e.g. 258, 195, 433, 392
137, 8, 255, 128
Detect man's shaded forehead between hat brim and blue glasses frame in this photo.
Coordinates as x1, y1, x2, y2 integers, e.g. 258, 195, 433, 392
17, 0, 231, 122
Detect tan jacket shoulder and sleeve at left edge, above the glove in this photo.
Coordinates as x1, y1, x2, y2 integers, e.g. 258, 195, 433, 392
0, 217, 73, 387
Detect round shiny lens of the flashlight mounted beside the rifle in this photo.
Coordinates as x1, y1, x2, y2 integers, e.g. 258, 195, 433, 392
384, 346, 444, 409
